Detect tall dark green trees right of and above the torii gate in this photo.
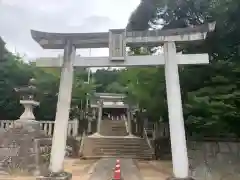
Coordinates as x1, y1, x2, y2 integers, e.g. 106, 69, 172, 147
127, 0, 240, 135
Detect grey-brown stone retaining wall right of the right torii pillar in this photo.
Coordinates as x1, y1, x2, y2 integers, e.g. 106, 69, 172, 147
156, 139, 240, 180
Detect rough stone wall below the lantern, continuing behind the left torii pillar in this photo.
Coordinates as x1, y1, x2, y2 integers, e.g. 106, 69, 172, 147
0, 126, 80, 175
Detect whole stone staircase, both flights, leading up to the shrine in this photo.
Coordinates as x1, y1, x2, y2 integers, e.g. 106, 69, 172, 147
81, 120, 153, 160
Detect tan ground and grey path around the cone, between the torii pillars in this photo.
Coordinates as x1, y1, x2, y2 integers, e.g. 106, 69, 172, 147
0, 158, 172, 180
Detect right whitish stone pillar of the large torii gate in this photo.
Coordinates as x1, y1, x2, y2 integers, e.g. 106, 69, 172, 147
164, 42, 188, 179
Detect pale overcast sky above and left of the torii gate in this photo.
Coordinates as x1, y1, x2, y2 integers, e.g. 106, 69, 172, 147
0, 0, 140, 59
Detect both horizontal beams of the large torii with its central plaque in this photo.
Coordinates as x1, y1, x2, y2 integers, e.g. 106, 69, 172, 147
31, 22, 215, 67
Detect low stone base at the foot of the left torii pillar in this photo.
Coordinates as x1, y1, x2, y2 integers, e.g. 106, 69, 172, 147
36, 172, 72, 180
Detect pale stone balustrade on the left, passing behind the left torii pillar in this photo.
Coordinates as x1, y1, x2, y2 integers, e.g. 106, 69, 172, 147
0, 119, 78, 137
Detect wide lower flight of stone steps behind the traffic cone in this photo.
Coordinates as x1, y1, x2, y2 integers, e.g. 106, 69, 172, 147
83, 137, 153, 159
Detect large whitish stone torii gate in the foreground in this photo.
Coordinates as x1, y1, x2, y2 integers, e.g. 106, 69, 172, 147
31, 23, 215, 179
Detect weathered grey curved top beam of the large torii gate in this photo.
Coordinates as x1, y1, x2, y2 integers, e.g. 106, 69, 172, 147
31, 22, 215, 49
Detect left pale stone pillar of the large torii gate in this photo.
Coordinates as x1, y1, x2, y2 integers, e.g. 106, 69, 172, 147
50, 40, 76, 174
